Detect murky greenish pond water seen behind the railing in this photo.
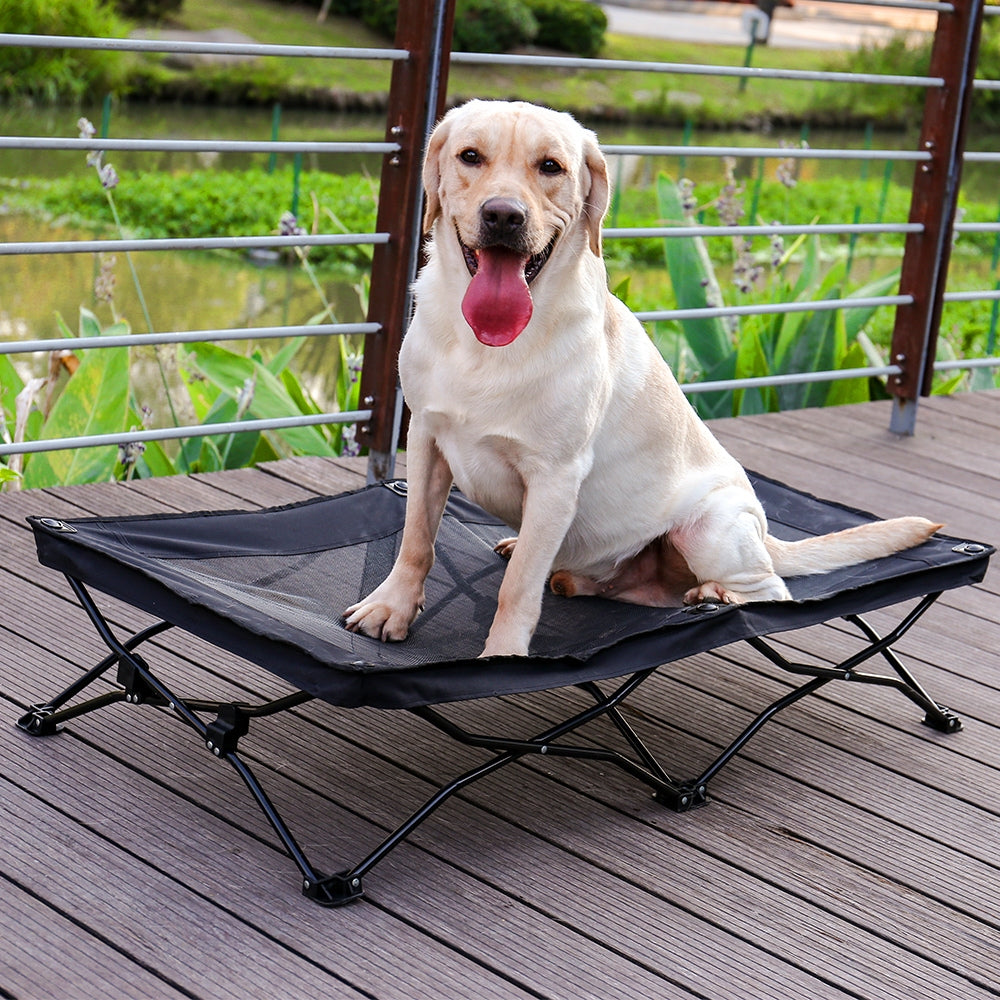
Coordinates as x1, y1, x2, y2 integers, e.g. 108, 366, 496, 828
0, 105, 996, 405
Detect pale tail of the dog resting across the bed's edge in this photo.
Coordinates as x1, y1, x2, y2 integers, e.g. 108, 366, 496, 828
767, 517, 944, 576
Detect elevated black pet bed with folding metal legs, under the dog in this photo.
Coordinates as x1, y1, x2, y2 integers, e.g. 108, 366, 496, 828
18, 476, 994, 905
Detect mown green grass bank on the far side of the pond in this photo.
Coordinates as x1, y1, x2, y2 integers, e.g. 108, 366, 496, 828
119, 0, 916, 127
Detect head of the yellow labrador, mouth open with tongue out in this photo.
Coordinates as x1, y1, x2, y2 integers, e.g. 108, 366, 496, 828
416, 101, 609, 347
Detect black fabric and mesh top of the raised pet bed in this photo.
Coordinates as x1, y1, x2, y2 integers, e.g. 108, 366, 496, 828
28, 476, 993, 708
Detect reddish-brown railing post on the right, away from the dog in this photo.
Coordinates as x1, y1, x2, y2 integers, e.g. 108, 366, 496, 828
888, 0, 983, 434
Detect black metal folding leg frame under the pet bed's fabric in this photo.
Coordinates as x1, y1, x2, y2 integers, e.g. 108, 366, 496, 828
17, 574, 962, 906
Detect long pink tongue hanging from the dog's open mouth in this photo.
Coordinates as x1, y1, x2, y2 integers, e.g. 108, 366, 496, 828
462, 247, 532, 347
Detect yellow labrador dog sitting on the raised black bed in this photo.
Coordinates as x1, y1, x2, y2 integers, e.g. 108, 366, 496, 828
345, 101, 940, 656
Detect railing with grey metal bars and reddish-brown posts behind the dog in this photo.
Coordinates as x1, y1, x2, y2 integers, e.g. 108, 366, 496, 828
0, 0, 1000, 479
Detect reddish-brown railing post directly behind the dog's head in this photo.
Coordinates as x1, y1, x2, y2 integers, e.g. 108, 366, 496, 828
358, 0, 455, 482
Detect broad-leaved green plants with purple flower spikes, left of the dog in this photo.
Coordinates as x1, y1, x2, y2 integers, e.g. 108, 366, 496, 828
0, 119, 366, 488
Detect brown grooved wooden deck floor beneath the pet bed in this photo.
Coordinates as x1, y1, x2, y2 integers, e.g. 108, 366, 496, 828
0, 393, 1000, 1000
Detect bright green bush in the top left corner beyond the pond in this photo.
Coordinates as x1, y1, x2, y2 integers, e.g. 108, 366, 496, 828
0, 0, 125, 101
